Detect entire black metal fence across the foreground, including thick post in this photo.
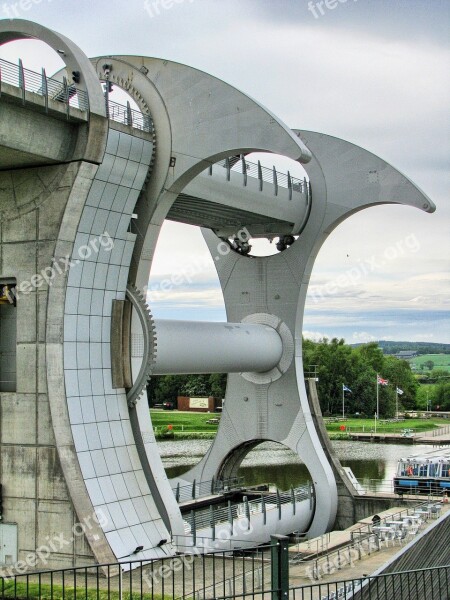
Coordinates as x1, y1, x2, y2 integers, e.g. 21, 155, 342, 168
0, 536, 450, 600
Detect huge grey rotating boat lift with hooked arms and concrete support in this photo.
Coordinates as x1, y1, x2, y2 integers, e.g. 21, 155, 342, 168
0, 20, 435, 566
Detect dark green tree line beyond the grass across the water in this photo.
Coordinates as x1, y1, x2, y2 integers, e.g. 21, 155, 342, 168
147, 338, 450, 418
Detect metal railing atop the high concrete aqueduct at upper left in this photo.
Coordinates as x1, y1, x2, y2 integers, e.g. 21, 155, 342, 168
0, 59, 154, 133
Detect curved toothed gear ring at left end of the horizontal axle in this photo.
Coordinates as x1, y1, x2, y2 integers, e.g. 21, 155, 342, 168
126, 284, 157, 408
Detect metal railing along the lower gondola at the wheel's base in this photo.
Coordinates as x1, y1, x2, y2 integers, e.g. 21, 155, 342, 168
183, 483, 314, 545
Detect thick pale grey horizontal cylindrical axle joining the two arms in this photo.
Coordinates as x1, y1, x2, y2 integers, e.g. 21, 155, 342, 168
153, 320, 283, 375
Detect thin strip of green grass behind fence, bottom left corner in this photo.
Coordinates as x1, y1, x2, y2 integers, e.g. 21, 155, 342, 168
0, 582, 163, 600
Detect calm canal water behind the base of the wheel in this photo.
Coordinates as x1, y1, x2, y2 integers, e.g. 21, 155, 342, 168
158, 440, 438, 491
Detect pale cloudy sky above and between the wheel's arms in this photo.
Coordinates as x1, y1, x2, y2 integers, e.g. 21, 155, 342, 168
0, 0, 450, 343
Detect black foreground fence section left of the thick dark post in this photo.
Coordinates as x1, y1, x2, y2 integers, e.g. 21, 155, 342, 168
0, 540, 280, 600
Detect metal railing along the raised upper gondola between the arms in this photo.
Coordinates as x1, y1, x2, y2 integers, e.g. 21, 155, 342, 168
208, 154, 311, 201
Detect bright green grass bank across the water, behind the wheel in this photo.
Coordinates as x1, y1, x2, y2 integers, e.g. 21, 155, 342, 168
150, 409, 449, 437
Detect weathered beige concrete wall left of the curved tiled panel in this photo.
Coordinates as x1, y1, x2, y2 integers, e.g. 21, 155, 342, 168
0, 164, 96, 567
